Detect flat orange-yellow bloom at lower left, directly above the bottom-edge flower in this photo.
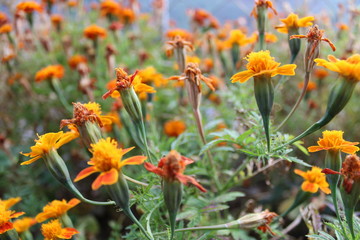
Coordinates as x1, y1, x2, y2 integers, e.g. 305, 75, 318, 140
35, 198, 80, 222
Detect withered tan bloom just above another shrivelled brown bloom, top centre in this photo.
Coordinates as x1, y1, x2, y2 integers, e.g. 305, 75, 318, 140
165, 35, 194, 72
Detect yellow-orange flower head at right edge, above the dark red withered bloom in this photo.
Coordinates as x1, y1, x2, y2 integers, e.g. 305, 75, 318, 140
308, 130, 359, 154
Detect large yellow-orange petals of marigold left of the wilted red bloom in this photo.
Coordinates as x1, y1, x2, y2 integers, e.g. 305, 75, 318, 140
74, 137, 146, 190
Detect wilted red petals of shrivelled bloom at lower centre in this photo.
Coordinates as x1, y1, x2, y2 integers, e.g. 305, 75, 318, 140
144, 150, 206, 192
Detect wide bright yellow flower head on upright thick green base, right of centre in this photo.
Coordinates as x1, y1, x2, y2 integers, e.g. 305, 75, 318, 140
231, 50, 296, 83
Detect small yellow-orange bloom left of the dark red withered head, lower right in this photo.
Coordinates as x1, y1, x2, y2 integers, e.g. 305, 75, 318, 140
294, 166, 331, 194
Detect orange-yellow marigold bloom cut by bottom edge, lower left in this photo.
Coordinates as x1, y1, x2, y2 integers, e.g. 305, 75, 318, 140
41, 219, 79, 240
